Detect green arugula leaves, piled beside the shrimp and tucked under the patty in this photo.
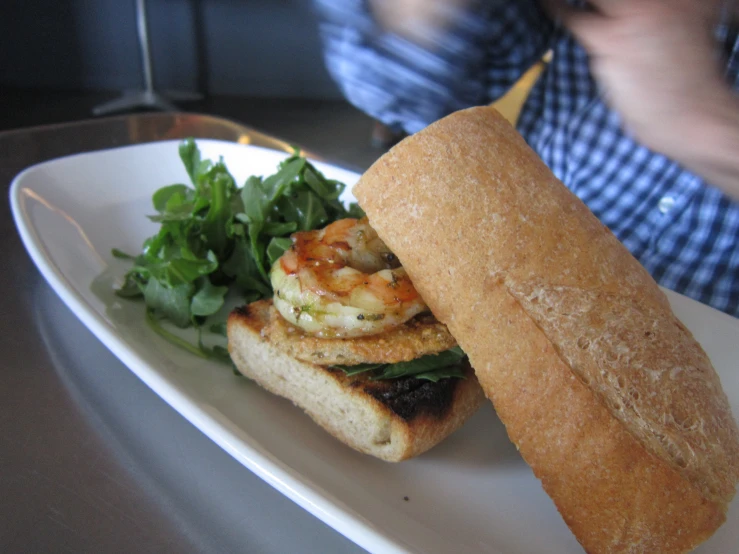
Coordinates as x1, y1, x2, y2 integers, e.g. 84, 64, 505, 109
118, 139, 468, 378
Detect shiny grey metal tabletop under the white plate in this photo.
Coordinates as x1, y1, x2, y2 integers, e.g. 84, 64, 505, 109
0, 114, 362, 553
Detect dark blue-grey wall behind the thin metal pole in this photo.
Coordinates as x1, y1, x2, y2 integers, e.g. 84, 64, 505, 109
0, 0, 340, 100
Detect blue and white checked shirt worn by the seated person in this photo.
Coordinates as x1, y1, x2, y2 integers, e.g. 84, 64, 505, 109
315, 0, 739, 317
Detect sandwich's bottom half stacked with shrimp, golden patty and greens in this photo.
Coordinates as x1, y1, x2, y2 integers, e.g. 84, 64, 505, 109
227, 218, 484, 462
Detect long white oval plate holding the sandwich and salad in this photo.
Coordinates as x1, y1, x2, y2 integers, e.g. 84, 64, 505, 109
10, 140, 739, 554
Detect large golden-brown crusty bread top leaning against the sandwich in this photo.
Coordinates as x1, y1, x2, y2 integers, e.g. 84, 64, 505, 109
354, 108, 739, 553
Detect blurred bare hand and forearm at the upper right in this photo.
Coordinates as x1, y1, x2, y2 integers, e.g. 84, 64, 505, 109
543, 0, 739, 197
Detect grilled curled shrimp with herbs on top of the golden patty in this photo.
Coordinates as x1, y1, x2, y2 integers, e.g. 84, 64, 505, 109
270, 218, 428, 338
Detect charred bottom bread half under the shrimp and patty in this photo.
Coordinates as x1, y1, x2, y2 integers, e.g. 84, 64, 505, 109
228, 300, 484, 462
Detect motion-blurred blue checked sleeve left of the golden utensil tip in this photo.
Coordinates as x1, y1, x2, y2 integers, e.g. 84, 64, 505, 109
314, 0, 551, 133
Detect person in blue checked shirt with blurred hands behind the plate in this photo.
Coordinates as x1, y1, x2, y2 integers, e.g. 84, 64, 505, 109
314, 0, 739, 317
